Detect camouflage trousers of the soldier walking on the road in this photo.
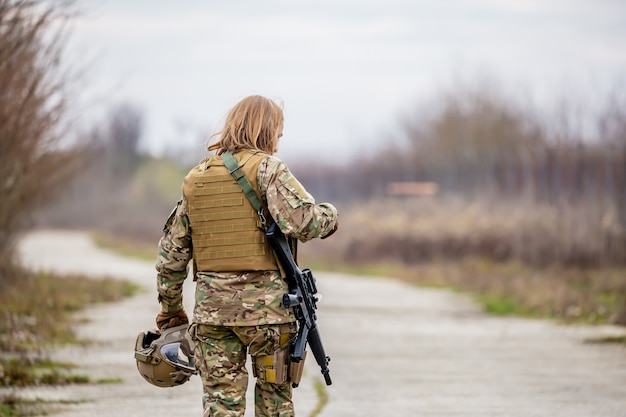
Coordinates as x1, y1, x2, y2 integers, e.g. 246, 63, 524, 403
189, 323, 296, 417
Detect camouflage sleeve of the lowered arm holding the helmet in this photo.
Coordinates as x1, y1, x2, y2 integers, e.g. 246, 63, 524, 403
155, 197, 193, 313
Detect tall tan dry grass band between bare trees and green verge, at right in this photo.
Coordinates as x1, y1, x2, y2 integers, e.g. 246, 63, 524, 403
316, 198, 623, 267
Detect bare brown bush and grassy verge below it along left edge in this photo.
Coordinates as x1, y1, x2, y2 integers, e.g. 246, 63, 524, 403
0, 0, 136, 417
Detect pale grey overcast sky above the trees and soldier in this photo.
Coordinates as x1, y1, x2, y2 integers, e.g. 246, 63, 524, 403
68, 0, 626, 160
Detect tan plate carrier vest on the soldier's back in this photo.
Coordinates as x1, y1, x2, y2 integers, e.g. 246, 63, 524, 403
183, 150, 279, 272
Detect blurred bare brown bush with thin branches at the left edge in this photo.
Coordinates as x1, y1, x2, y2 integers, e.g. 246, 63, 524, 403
0, 0, 75, 286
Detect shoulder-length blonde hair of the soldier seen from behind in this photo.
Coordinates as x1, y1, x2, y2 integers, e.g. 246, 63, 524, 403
207, 96, 284, 155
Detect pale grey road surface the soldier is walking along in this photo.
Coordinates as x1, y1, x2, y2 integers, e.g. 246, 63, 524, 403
13, 231, 626, 417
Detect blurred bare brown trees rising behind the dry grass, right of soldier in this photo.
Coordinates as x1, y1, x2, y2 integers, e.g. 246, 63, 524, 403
293, 88, 626, 204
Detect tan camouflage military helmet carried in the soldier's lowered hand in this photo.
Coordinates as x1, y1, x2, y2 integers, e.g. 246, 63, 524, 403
135, 324, 196, 387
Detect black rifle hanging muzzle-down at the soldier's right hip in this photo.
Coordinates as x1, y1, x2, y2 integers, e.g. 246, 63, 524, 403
265, 222, 332, 388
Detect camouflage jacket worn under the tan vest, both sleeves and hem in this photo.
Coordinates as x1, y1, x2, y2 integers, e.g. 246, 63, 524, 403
156, 156, 337, 326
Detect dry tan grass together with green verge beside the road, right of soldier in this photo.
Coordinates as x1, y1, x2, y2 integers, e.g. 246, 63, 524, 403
300, 199, 626, 324
